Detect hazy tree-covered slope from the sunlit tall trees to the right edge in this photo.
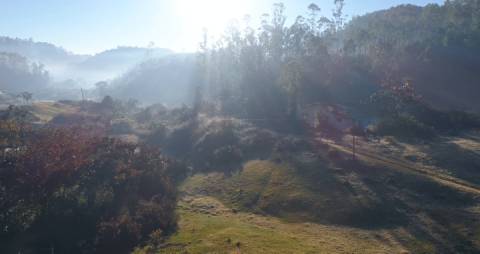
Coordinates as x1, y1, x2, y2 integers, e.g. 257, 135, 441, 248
198, 0, 480, 129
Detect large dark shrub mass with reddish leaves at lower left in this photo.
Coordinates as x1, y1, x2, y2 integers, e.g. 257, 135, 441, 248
0, 128, 179, 253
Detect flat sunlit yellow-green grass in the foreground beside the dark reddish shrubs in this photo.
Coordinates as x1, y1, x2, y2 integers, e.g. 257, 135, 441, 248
137, 196, 410, 253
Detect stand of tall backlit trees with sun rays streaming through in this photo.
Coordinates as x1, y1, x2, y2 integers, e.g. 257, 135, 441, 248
198, 1, 343, 120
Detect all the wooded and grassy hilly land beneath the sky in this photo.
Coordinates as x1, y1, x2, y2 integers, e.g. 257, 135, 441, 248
0, 0, 480, 254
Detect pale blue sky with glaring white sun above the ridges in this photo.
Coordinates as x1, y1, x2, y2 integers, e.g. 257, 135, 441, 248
0, 0, 444, 54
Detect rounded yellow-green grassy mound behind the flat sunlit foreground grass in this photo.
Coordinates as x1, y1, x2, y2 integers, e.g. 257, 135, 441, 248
182, 161, 314, 216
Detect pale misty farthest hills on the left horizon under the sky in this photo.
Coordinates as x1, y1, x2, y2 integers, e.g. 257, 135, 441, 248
0, 37, 173, 86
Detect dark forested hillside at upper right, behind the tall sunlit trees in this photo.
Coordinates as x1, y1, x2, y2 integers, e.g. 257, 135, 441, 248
341, 1, 480, 112
